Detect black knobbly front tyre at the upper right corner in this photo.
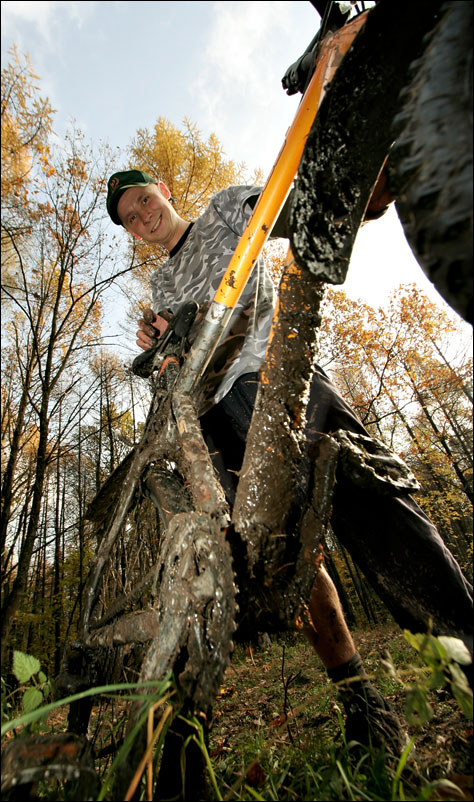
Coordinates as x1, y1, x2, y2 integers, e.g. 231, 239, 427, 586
389, 2, 473, 323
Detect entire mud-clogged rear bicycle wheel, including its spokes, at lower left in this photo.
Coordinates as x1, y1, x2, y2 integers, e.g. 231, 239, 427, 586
58, 412, 235, 798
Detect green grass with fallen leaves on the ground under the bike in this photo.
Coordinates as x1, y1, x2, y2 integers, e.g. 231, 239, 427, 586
1, 625, 472, 802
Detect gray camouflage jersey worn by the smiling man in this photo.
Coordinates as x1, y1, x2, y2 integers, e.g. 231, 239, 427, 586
151, 186, 275, 415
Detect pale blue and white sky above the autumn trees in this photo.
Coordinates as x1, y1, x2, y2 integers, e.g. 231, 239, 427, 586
1, 0, 466, 324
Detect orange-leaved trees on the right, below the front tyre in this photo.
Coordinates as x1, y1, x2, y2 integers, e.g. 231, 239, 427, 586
318, 285, 472, 556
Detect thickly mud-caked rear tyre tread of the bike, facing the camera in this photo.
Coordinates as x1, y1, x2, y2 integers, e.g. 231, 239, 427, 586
110, 462, 235, 799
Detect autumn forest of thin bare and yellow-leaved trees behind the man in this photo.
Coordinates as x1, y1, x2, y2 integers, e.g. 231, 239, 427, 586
1, 50, 473, 792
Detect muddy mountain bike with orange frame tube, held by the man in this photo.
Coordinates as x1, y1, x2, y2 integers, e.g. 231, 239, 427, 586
2, 0, 472, 799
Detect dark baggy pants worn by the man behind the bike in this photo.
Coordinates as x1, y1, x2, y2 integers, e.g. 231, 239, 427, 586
201, 368, 472, 653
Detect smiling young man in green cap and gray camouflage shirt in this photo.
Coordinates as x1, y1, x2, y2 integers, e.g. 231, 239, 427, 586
107, 170, 472, 748
